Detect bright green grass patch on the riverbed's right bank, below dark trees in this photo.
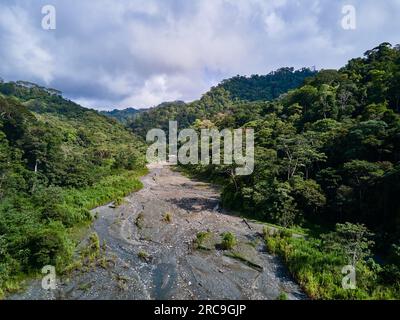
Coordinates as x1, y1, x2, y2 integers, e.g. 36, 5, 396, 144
265, 233, 400, 300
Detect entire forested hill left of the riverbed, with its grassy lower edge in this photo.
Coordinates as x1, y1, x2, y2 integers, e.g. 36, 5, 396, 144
0, 82, 145, 298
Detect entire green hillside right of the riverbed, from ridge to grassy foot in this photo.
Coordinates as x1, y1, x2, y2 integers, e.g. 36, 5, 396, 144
131, 43, 400, 299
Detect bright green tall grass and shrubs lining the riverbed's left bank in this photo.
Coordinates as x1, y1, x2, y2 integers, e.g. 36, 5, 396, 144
0, 169, 147, 299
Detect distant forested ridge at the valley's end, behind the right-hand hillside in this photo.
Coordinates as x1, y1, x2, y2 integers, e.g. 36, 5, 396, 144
130, 68, 315, 137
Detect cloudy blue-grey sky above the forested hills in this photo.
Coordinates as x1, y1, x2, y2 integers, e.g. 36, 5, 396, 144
0, 0, 400, 110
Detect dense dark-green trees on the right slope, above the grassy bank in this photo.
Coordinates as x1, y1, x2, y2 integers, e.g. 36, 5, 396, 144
173, 43, 400, 248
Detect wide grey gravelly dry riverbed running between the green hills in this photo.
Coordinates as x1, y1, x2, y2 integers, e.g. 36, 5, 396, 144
10, 166, 306, 300
